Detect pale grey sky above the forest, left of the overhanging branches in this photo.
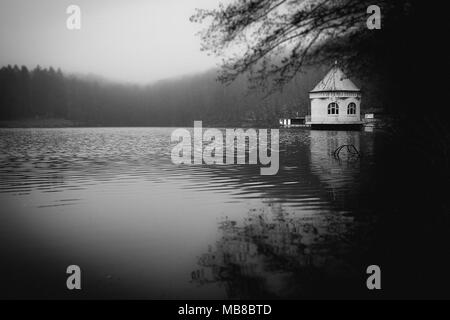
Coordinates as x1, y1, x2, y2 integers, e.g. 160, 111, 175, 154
0, 0, 229, 84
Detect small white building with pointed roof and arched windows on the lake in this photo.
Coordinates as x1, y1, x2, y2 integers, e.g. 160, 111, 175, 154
307, 64, 363, 128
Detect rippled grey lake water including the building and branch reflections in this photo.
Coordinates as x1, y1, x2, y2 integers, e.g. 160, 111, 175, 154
0, 128, 377, 299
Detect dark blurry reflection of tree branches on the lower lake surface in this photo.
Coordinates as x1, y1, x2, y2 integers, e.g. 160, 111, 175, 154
192, 206, 359, 298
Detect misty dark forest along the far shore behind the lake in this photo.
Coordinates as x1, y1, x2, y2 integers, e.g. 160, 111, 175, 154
0, 66, 376, 126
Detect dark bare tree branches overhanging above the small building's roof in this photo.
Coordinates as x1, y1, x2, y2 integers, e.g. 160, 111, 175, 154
191, 0, 411, 95
